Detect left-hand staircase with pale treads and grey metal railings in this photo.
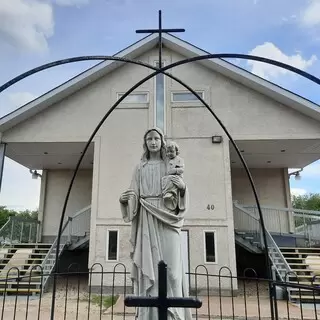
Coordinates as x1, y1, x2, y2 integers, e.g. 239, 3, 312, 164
0, 206, 91, 295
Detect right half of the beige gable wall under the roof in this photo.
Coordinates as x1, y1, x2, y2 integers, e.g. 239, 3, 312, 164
168, 50, 320, 139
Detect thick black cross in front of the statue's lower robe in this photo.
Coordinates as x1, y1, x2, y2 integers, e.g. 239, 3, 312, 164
124, 261, 202, 320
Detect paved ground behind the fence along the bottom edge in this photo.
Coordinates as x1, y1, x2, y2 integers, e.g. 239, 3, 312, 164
0, 294, 320, 320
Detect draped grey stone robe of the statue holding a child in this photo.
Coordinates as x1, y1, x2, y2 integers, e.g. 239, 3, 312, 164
121, 160, 191, 320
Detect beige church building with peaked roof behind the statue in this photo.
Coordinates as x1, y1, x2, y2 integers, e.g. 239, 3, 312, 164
0, 34, 320, 296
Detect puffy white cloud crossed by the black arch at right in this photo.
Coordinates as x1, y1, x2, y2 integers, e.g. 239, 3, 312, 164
248, 42, 317, 79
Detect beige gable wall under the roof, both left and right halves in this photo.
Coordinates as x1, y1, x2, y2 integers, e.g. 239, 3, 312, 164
3, 50, 320, 142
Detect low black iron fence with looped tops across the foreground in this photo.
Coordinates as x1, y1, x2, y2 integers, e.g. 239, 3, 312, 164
0, 264, 320, 320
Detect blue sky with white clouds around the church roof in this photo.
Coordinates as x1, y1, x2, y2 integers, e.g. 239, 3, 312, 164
0, 0, 320, 209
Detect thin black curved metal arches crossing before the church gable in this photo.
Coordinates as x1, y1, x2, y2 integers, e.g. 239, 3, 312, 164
0, 53, 320, 319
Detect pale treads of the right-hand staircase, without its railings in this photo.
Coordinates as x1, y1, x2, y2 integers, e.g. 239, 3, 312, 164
280, 247, 320, 303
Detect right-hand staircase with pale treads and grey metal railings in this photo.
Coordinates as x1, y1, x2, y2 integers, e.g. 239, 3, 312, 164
233, 202, 320, 303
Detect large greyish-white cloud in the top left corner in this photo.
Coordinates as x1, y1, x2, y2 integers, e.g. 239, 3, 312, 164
0, 0, 54, 51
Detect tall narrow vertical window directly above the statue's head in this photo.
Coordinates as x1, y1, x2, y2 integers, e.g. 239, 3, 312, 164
155, 62, 165, 132
